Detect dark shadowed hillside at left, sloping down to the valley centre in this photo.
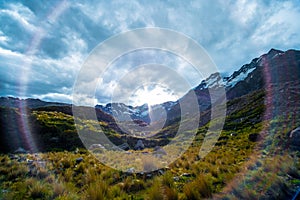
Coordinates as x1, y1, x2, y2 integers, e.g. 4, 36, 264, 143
0, 106, 169, 153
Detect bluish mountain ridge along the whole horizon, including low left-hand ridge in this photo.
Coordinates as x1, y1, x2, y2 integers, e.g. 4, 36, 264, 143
0, 48, 300, 124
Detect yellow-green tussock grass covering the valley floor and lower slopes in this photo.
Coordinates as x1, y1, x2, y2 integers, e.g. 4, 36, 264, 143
0, 89, 300, 200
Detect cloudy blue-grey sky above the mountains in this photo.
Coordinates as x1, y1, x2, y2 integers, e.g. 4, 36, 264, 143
0, 0, 300, 105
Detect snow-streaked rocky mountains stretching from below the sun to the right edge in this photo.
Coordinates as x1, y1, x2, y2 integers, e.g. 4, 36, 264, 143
96, 49, 300, 124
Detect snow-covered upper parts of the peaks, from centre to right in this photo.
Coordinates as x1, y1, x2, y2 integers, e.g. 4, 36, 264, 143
97, 49, 294, 123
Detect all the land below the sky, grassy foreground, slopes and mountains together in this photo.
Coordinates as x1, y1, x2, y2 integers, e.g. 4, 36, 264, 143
0, 49, 300, 199
